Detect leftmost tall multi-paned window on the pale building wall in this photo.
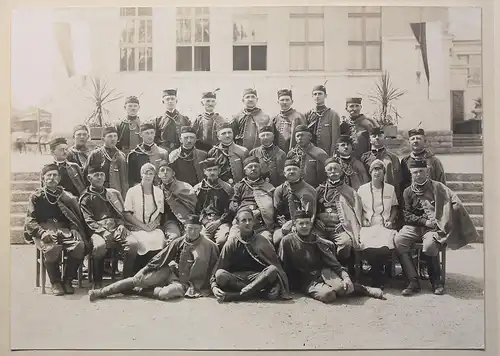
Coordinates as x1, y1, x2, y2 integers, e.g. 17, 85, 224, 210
120, 7, 153, 72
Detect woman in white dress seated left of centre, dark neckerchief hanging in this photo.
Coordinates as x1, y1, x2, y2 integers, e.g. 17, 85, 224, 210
124, 163, 166, 255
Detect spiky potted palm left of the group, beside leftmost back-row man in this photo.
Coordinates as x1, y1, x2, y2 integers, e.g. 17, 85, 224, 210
85, 77, 123, 140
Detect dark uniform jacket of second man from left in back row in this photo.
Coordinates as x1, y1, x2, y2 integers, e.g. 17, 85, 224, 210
154, 110, 191, 152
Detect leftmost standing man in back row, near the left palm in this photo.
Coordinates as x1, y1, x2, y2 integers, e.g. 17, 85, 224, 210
116, 96, 141, 156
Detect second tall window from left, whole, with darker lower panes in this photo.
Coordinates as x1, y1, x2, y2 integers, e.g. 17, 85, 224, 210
176, 7, 210, 72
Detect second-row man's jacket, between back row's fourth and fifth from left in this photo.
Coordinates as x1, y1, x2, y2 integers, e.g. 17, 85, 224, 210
250, 146, 286, 187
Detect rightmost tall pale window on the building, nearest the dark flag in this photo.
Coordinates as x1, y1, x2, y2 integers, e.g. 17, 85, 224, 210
347, 6, 382, 70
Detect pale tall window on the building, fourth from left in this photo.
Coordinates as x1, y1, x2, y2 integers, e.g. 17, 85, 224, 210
289, 6, 325, 71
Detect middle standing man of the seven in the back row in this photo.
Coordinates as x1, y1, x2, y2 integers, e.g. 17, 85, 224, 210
232, 89, 271, 151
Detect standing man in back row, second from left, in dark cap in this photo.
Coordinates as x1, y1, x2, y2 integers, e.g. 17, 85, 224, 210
155, 89, 191, 152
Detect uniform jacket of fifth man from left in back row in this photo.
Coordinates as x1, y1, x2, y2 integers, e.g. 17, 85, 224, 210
272, 109, 307, 153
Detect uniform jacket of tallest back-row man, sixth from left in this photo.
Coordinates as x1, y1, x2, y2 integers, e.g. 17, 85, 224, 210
305, 108, 340, 157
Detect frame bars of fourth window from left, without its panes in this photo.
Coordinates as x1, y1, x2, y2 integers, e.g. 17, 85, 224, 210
288, 6, 326, 72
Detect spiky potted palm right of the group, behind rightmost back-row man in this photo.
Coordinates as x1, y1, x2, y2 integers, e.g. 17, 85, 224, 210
368, 72, 406, 137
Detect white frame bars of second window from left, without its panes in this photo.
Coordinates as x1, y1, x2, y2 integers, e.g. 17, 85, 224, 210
175, 6, 212, 73
